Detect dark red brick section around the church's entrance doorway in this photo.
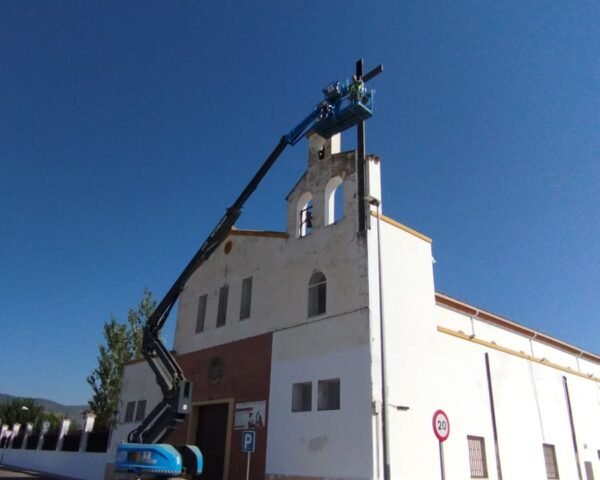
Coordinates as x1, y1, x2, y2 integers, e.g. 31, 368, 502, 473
169, 332, 272, 480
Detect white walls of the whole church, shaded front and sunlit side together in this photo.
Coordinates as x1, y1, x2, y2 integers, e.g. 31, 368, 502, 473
113, 131, 600, 480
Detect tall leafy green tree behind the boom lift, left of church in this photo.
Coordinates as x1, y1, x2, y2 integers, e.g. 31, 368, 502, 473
87, 289, 156, 428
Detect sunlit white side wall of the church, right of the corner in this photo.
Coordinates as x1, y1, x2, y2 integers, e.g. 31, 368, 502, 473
369, 215, 600, 479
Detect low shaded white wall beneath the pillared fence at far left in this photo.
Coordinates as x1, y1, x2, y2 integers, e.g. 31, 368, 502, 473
4, 449, 107, 480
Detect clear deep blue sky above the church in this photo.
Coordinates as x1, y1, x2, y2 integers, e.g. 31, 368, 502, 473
0, 0, 600, 403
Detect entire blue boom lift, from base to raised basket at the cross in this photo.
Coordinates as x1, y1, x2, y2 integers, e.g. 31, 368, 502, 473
115, 65, 383, 478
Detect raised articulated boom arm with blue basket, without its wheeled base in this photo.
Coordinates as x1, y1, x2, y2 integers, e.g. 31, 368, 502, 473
128, 67, 381, 443
